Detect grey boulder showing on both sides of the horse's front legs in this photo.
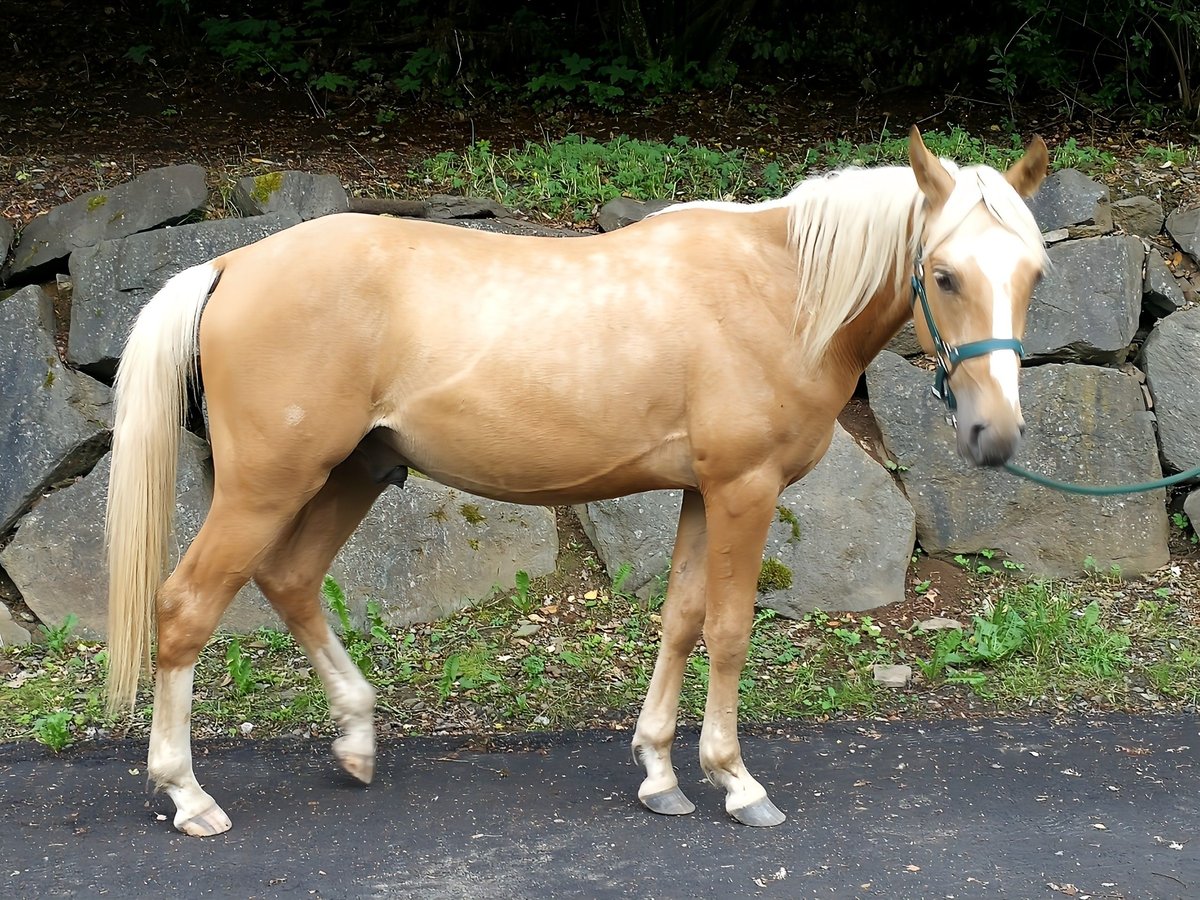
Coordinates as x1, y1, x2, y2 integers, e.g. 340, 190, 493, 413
576, 425, 914, 618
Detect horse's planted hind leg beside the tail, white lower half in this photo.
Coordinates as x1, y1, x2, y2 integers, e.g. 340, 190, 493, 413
146, 487, 320, 836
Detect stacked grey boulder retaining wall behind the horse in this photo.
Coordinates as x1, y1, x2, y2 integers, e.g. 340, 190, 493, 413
0, 166, 1200, 642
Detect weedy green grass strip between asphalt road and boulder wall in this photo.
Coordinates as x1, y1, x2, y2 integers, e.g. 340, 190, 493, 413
0, 572, 1200, 750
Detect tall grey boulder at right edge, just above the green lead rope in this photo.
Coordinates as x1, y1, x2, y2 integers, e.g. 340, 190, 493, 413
1140, 308, 1200, 472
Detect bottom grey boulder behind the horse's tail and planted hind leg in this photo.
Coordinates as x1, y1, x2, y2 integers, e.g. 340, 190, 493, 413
0, 432, 280, 638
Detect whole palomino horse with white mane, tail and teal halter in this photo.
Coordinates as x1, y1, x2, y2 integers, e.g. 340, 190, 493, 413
108, 128, 1046, 835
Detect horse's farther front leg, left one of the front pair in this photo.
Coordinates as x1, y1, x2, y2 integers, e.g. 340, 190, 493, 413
634, 491, 704, 816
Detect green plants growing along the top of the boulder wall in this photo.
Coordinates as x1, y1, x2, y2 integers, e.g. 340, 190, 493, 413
409, 128, 1123, 221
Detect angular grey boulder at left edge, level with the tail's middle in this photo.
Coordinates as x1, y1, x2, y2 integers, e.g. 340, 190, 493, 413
0, 286, 112, 536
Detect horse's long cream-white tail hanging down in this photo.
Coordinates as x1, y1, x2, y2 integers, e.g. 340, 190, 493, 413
104, 263, 221, 713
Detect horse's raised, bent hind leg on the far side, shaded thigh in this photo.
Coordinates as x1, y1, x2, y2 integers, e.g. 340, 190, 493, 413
254, 452, 386, 784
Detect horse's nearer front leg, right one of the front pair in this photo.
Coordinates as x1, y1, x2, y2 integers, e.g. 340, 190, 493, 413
700, 475, 785, 826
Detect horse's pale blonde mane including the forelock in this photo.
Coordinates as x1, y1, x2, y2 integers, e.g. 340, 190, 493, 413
654, 154, 1045, 366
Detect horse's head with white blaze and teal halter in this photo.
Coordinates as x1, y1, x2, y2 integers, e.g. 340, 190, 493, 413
908, 127, 1048, 466
